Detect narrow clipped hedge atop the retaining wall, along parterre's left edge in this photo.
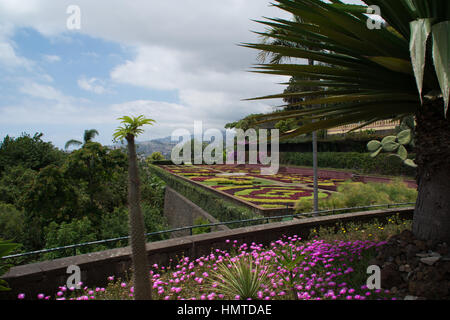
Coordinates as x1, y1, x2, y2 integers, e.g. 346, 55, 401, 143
149, 165, 262, 228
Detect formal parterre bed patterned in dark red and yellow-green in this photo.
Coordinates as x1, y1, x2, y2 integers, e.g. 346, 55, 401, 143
160, 165, 414, 209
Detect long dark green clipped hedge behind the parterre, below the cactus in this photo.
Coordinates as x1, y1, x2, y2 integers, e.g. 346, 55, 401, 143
280, 152, 416, 177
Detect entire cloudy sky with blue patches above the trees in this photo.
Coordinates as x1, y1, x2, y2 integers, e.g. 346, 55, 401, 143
0, 0, 364, 148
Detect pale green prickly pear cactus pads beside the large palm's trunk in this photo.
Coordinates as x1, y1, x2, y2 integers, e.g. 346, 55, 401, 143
367, 129, 417, 168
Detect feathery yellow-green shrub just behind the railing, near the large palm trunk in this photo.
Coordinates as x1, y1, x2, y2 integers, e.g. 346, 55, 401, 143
295, 181, 417, 213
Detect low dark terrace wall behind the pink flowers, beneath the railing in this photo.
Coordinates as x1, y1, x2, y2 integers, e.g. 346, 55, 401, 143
0, 208, 414, 299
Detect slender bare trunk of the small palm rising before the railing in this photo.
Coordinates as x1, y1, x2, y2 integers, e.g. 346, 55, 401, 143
126, 134, 152, 300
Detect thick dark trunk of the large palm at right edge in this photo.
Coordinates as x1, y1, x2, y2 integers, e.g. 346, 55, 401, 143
413, 100, 450, 243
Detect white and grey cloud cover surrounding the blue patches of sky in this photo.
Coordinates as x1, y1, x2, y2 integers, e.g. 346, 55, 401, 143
0, 0, 294, 144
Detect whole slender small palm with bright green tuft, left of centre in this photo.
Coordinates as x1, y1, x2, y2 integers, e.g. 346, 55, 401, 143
114, 116, 155, 300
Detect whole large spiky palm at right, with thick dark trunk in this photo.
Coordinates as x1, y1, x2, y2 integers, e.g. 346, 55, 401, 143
243, 0, 450, 242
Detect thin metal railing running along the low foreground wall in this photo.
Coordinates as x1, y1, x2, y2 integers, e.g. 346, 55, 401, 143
0, 202, 415, 261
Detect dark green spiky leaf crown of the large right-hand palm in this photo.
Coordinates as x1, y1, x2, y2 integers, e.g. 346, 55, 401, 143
242, 0, 450, 138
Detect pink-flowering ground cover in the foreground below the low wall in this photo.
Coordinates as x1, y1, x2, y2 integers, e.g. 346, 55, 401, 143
18, 236, 396, 300
